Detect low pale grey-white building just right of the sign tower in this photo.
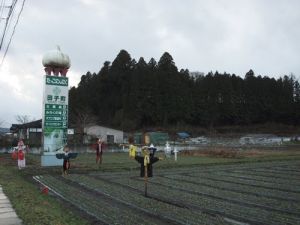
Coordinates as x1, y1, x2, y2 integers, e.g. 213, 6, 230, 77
84, 125, 124, 143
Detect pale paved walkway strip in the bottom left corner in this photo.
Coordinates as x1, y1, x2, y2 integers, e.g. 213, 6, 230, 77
0, 185, 22, 225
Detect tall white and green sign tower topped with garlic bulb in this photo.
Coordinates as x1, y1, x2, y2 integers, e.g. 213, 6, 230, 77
41, 46, 70, 166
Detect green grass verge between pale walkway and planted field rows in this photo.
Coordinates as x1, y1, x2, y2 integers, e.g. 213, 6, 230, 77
0, 154, 90, 225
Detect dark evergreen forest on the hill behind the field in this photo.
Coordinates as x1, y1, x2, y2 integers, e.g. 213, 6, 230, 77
69, 50, 300, 131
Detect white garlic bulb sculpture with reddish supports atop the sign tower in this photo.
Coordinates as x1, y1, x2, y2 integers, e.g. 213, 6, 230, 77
42, 46, 71, 77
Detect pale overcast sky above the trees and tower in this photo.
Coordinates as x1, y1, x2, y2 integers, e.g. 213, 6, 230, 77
0, 0, 300, 127
